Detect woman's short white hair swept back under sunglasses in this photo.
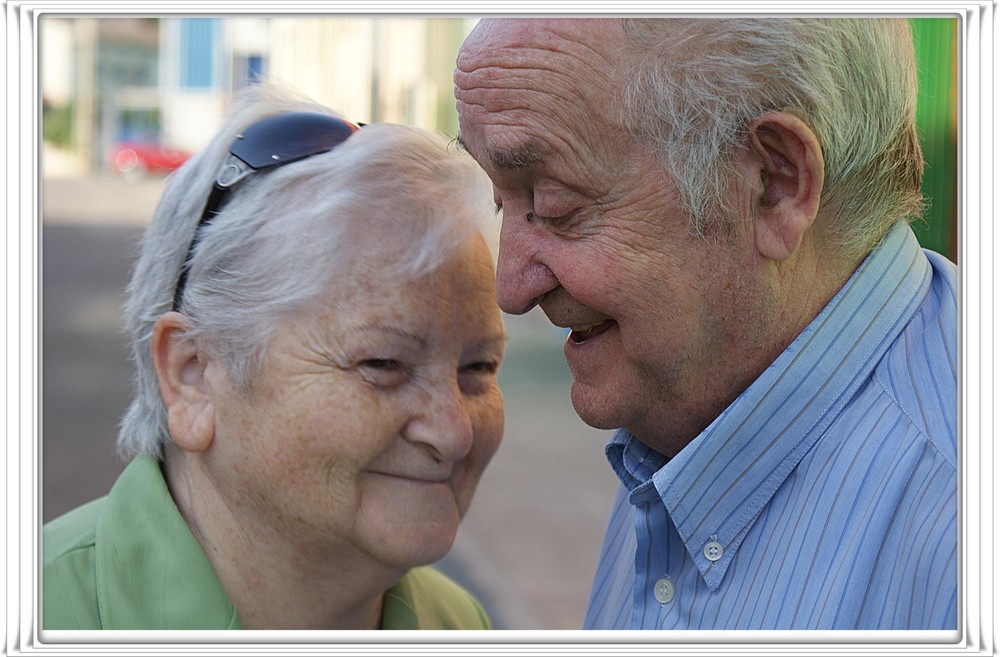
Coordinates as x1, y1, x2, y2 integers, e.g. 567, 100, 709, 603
118, 84, 498, 457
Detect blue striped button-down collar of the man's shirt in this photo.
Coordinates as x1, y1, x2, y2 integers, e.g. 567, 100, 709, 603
606, 222, 931, 591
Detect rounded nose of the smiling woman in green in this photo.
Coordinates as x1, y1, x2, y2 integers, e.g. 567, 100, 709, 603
404, 380, 474, 463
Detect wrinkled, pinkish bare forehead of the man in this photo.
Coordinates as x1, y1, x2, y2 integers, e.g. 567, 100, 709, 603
455, 18, 624, 175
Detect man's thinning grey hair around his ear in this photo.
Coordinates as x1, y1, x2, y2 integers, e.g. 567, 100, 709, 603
622, 18, 923, 260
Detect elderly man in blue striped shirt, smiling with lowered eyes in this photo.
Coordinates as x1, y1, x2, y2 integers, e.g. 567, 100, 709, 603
455, 18, 958, 629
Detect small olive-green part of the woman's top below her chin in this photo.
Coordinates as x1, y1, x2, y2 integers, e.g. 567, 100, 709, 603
382, 566, 493, 630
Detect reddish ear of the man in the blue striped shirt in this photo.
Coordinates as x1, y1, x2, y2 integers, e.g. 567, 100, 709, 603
750, 112, 823, 260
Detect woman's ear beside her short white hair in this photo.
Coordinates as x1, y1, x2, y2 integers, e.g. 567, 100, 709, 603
150, 312, 215, 452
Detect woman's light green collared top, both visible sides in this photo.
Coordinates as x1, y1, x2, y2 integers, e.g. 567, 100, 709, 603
42, 457, 491, 630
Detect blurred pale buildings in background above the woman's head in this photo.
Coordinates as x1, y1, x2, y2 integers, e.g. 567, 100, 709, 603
40, 16, 474, 173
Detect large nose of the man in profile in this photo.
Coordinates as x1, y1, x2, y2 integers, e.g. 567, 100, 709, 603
496, 208, 559, 315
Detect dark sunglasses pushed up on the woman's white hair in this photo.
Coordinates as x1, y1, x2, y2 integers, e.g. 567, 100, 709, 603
173, 112, 358, 310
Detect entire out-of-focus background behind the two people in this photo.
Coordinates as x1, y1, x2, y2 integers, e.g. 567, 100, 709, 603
38, 16, 958, 629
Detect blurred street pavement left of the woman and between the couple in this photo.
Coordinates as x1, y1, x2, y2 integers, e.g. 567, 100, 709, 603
39, 175, 617, 630
